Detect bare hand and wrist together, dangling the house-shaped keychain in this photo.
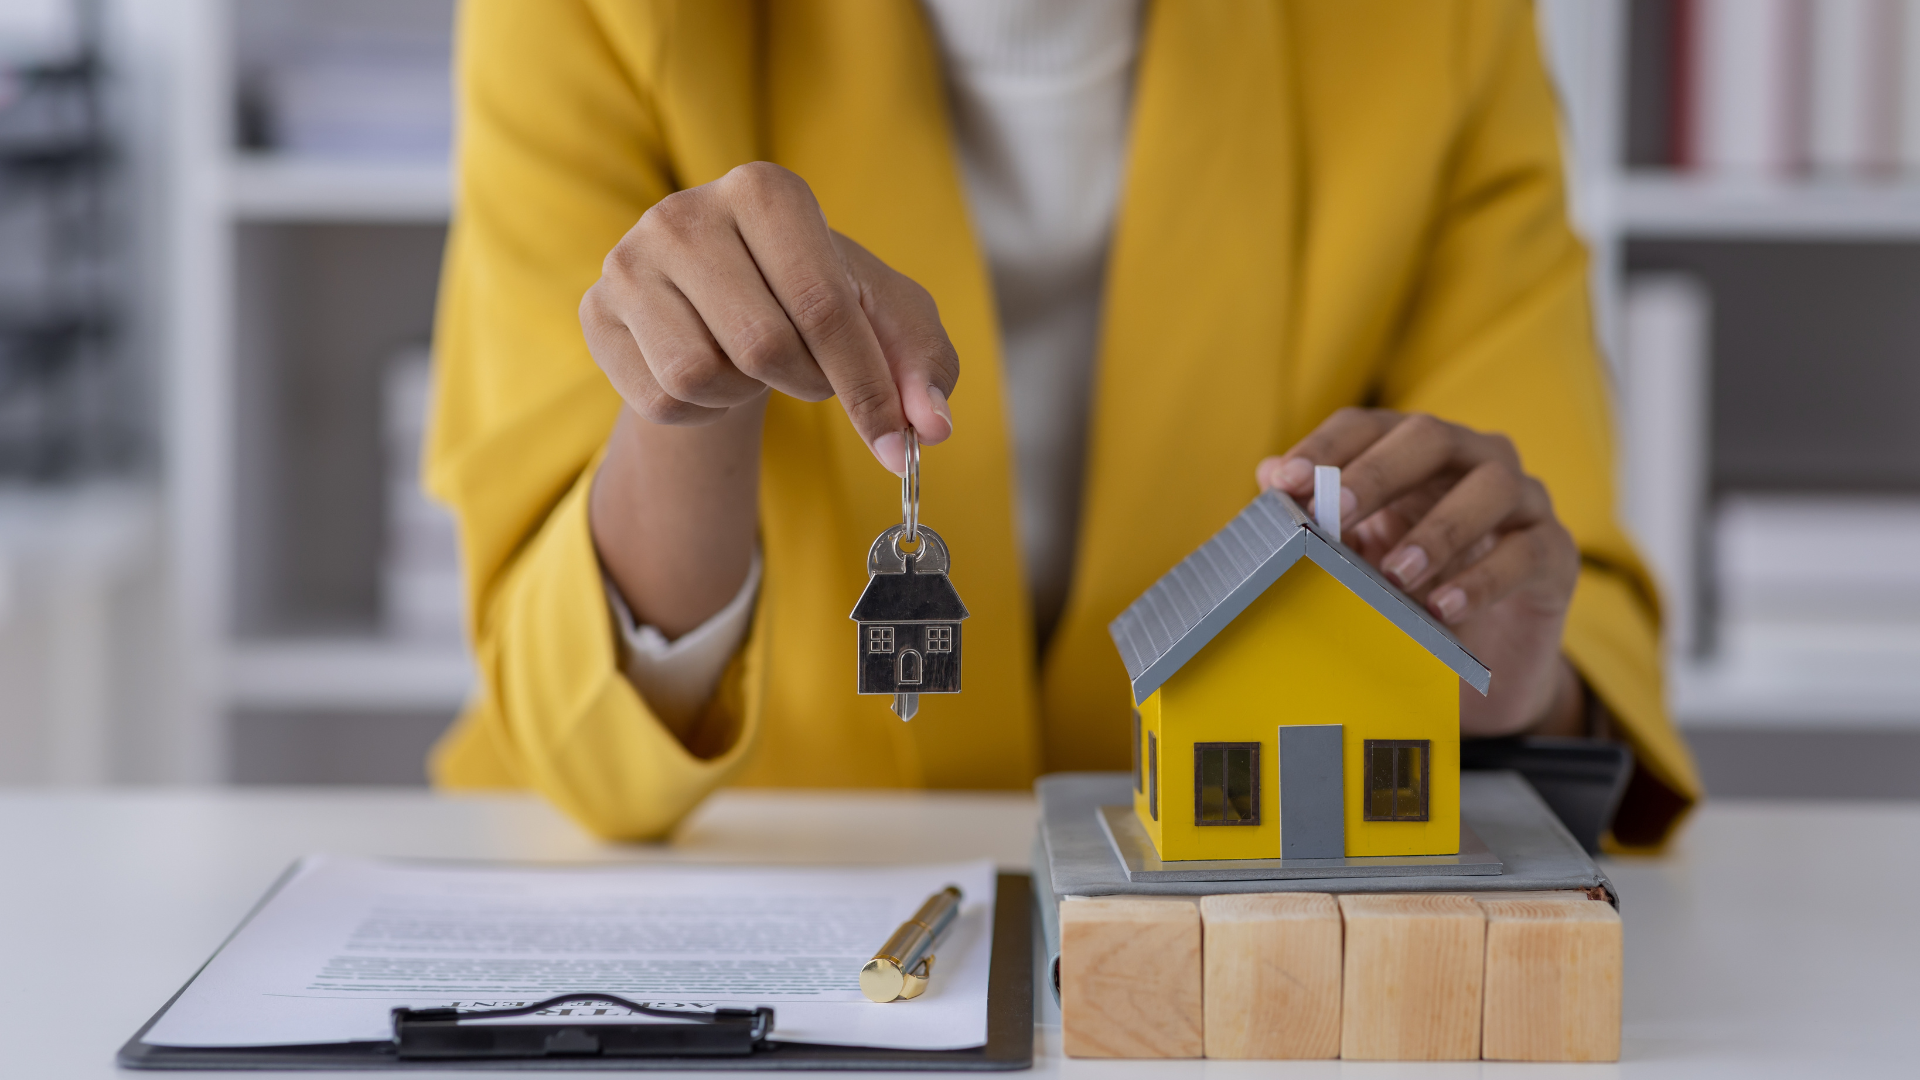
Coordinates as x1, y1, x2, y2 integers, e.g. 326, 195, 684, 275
580, 161, 960, 653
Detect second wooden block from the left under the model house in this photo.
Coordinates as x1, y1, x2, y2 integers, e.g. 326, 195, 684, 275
1200, 892, 1340, 1059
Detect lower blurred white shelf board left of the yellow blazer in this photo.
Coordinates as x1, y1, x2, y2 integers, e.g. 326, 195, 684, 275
227, 638, 474, 709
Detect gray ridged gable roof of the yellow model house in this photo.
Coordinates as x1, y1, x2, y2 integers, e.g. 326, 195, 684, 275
1106, 492, 1492, 701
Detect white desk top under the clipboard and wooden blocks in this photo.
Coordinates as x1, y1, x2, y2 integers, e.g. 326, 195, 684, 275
0, 790, 1920, 1080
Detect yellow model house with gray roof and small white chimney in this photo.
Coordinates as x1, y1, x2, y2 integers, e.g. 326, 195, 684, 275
1110, 469, 1490, 861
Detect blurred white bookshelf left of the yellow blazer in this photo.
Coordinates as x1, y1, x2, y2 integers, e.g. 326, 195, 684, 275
169, 0, 474, 782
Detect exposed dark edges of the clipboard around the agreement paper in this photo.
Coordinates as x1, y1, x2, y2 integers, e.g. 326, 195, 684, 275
117, 871, 1033, 1072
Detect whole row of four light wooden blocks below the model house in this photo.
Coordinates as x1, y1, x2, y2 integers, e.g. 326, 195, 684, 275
1060, 892, 1620, 1061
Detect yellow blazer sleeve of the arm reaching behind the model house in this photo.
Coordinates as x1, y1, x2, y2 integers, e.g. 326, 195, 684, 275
1380, 0, 1701, 847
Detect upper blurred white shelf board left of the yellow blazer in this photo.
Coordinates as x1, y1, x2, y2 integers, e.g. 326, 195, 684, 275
227, 154, 453, 225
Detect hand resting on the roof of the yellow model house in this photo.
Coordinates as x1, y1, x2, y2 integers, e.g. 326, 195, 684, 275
1254, 407, 1584, 736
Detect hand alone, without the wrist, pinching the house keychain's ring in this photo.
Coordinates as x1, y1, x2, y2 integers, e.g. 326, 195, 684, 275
580, 161, 960, 475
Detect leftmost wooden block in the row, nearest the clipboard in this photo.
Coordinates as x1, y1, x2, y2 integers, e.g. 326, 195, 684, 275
1060, 897, 1206, 1057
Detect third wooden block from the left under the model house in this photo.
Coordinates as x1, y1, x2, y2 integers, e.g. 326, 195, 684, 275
1340, 896, 1486, 1061
